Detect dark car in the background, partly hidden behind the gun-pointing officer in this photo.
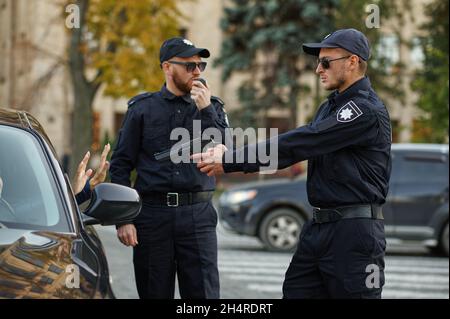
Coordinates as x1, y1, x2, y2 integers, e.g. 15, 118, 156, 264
219, 144, 449, 256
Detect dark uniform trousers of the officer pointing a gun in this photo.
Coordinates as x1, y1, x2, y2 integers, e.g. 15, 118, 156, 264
283, 218, 386, 299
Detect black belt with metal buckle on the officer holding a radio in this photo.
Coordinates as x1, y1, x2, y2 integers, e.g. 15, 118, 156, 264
142, 191, 214, 207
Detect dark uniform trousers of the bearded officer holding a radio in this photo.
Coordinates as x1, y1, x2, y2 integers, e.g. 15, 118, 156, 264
133, 201, 219, 299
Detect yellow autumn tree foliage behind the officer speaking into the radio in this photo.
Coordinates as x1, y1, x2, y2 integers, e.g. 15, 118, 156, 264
85, 0, 181, 97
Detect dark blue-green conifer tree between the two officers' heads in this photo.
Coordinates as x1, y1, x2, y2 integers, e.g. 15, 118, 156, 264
216, 0, 338, 127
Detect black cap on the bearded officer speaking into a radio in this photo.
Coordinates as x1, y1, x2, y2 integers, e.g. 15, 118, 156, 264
159, 37, 210, 63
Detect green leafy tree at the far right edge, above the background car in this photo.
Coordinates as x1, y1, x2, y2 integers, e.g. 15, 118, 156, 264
412, 0, 449, 143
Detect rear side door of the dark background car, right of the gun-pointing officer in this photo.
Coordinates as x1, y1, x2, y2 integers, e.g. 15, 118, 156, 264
389, 151, 448, 238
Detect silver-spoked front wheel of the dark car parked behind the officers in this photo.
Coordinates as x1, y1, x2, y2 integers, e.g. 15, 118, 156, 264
259, 208, 305, 251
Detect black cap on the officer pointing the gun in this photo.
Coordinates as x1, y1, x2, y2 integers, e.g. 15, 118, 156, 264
303, 29, 370, 61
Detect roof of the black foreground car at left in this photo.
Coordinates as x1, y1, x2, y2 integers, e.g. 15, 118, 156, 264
0, 108, 56, 155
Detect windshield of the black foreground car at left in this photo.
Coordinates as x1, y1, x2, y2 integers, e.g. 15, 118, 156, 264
0, 126, 67, 230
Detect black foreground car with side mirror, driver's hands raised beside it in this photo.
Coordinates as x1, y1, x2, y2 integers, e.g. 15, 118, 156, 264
0, 109, 141, 298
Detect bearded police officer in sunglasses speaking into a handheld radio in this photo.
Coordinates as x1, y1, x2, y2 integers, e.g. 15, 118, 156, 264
110, 37, 228, 299
